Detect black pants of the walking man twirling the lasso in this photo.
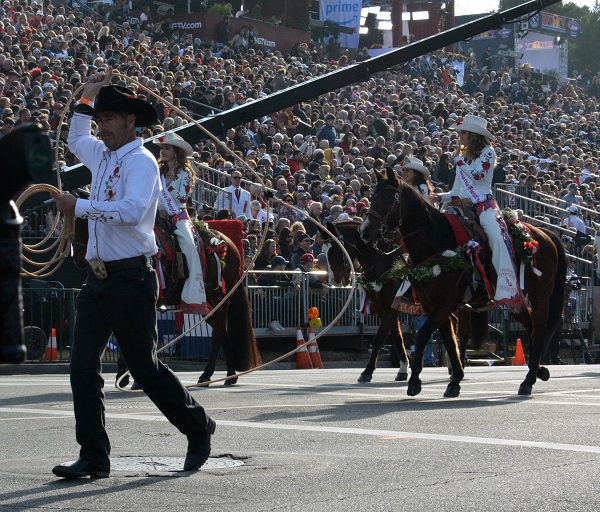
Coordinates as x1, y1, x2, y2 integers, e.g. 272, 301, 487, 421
71, 266, 206, 465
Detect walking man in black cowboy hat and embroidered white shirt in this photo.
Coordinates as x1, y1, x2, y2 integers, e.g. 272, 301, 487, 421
52, 70, 215, 478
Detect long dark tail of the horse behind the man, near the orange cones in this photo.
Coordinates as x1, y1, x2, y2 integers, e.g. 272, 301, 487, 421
227, 285, 261, 371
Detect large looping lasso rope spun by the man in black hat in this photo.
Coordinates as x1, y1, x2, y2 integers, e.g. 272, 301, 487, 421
17, 68, 356, 393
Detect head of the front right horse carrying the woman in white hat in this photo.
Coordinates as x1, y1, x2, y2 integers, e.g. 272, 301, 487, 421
360, 167, 402, 243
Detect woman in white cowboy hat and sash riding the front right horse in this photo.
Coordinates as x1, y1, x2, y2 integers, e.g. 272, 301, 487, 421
434, 115, 525, 313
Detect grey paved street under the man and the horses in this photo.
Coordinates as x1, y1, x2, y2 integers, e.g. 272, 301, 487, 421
0, 365, 600, 512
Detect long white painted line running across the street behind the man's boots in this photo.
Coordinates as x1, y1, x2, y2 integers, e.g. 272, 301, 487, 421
0, 407, 600, 454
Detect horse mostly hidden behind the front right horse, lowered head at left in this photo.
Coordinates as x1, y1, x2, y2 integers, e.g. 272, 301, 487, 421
323, 220, 488, 382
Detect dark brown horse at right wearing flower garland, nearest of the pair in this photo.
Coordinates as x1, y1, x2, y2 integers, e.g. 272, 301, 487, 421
360, 168, 567, 397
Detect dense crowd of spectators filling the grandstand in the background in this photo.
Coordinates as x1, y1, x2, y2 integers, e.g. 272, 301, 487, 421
0, 0, 600, 274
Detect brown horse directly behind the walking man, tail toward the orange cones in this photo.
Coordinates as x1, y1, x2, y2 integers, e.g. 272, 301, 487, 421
73, 214, 260, 385
